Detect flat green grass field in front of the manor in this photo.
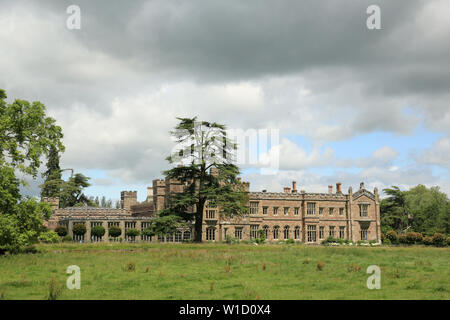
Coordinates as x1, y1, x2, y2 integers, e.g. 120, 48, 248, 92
0, 243, 450, 300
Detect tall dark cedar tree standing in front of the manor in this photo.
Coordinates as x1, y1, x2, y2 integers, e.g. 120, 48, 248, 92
161, 117, 248, 242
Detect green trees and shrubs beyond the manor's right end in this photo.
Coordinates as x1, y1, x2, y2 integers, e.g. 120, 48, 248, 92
380, 184, 450, 236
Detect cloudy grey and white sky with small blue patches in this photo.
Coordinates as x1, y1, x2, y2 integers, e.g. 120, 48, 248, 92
0, 0, 450, 200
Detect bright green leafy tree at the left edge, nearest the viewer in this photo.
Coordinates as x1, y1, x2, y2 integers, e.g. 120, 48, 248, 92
0, 89, 64, 250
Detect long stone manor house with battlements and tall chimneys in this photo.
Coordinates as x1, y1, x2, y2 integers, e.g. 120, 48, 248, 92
43, 179, 381, 244
